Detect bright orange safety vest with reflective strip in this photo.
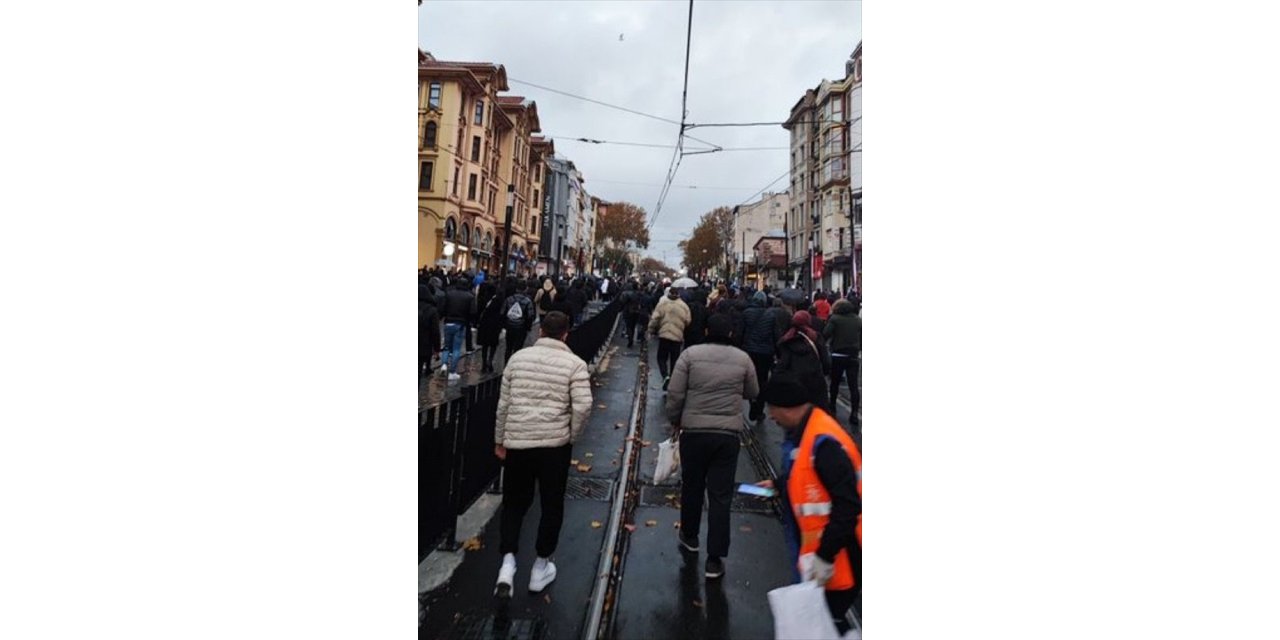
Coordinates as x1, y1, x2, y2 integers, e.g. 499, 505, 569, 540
787, 407, 863, 591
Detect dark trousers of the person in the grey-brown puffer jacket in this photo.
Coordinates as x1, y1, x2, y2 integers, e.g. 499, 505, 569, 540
680, 431, 740, 558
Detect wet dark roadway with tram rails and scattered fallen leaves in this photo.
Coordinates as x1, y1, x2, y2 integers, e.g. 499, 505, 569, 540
420, 317, 849, 640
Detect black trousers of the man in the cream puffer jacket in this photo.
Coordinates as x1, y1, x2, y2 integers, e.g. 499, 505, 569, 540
498, 444, 573, 558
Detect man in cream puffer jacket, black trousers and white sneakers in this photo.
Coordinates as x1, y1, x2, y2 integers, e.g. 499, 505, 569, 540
494, 311, 591, 598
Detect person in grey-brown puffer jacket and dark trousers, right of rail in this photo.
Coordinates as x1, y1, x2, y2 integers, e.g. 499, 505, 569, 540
666, 315, 760, 580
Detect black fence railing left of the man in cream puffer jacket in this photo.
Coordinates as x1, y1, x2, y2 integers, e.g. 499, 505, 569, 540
417, 301, 621, 562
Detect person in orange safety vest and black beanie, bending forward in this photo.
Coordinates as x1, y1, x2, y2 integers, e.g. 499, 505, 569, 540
762, 374, 863, 634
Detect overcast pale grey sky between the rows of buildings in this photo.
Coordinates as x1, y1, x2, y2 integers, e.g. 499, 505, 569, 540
417, 0, 863, 266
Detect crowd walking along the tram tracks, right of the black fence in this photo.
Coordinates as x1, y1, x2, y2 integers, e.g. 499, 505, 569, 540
478, 270, 861, 632
